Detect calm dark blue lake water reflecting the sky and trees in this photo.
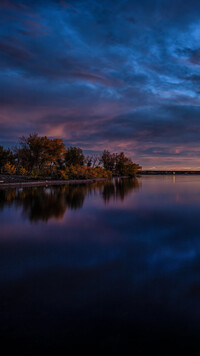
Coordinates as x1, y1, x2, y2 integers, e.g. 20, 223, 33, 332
0, 176, 200, 355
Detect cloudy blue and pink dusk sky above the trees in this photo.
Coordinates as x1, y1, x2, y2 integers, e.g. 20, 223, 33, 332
0, 0, 200, 169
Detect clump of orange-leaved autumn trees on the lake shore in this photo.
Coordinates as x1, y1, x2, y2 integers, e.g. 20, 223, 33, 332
0, 134, 141, 179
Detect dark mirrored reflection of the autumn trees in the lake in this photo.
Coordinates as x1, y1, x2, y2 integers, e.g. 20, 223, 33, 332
0, 178, 141, 222
